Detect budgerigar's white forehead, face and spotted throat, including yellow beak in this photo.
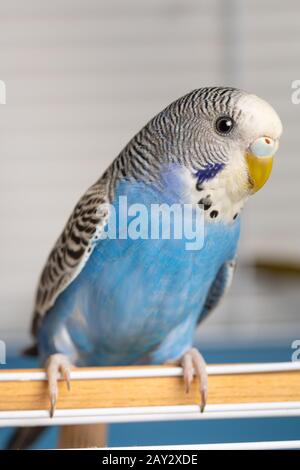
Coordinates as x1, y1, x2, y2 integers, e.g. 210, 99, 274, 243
188, 94, 282, 223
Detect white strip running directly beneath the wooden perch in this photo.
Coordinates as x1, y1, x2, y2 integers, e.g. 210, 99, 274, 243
0, 402, 300, 427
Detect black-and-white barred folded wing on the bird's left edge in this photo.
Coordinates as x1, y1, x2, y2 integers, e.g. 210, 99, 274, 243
32, 173, 113, 335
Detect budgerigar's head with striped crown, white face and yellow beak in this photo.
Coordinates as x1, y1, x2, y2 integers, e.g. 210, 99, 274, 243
164, 87, 282, 200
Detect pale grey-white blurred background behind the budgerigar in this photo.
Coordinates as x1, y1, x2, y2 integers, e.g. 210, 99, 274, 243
0, 0, 300, 349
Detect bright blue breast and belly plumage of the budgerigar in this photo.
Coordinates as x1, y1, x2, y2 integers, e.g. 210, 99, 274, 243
38, 176, 240, 365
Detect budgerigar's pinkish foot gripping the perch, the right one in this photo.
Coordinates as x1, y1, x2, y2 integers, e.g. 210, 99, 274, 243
180, 348, 208, 413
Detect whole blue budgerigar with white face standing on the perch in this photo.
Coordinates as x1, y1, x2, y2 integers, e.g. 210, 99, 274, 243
8, 87, 282, 448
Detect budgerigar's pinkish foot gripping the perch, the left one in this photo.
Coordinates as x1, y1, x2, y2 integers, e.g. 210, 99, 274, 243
45, 354, 71, 418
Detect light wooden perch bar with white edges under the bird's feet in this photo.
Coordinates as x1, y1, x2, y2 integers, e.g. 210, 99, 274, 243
0, 363, 300, 426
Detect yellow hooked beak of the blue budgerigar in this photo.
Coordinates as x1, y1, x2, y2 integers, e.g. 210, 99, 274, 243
246, 153, 273, 193
